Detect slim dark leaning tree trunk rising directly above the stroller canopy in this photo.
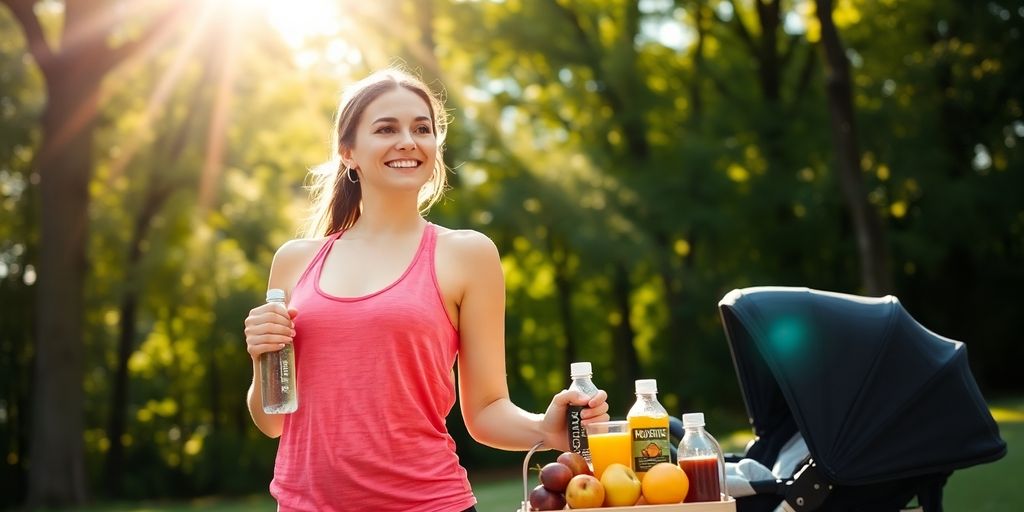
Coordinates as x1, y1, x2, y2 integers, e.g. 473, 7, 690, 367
816, 0, 893, 295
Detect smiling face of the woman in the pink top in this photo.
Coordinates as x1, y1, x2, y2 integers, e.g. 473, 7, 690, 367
341, 87, 437, 191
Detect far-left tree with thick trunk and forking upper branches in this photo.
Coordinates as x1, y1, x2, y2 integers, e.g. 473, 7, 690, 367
2, 0, 190, 507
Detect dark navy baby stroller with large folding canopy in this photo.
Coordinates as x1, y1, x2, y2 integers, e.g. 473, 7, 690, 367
676, 287, 1007, 512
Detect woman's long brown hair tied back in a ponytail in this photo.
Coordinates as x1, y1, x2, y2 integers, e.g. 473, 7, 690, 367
305, 68, 447, 237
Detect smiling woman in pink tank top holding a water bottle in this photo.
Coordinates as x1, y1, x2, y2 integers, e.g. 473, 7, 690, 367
246, 70, 608, 512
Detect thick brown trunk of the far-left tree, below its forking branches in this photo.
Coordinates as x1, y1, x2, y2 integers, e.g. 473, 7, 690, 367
28, 68, 99, 507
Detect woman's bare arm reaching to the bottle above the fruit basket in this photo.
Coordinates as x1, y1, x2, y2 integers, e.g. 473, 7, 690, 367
452, 231, 608, 451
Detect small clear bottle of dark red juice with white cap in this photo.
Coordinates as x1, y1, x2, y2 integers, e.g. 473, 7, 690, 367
676, 413, 725, 503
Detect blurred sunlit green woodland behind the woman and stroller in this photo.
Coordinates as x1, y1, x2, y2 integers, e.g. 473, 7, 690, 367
0, 0, 1024, 507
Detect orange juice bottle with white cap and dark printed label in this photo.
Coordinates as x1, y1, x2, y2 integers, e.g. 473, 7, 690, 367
626, 379, 672, 480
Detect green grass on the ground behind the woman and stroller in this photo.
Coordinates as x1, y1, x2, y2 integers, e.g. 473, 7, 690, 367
61, 398, 1024, 512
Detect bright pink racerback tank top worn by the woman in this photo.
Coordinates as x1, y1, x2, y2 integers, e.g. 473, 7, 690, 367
270, 223, 476, 512
